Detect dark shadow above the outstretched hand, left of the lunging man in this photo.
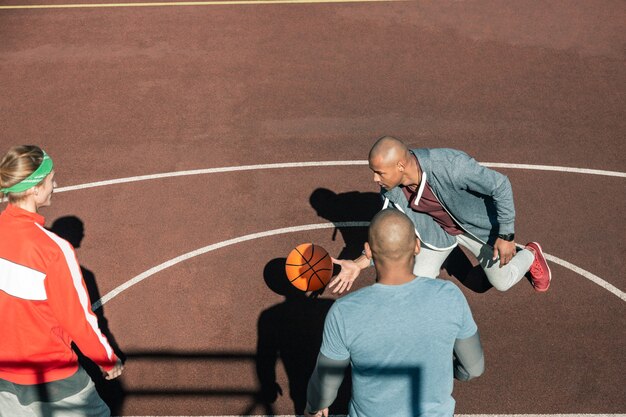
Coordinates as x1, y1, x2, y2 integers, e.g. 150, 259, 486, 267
309, 188, 382, 259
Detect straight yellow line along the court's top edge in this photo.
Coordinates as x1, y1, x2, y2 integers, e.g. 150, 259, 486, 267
0, 0, 409, 10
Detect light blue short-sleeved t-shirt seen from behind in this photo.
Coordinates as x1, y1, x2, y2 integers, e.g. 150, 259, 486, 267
321, 277, 477, 417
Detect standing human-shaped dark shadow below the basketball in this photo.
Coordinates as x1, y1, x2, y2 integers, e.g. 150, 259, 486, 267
255, 258, 351, 415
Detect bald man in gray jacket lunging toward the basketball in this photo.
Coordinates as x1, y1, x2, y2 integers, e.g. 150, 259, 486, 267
329, 136, 552, 293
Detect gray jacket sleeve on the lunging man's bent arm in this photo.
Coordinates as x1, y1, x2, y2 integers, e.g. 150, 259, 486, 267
453, 152, 515, 234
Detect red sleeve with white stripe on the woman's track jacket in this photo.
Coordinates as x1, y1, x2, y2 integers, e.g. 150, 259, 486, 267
46, 240, 117, 371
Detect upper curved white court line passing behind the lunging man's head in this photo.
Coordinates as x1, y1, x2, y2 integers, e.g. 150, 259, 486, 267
54, 160, 626, 193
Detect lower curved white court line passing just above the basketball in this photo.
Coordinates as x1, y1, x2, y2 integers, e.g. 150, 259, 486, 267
92, 222, 626, 311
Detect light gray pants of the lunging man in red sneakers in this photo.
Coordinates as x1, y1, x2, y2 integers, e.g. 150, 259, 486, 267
413, 233, 535, 291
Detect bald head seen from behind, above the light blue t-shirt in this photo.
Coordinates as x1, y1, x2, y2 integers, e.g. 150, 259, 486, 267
368, 209, 417, 262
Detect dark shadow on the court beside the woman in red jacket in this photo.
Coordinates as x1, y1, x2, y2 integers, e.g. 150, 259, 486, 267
50, 216, 126, 415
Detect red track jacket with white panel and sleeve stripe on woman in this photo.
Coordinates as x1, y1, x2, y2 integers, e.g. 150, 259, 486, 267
0, 204, 117, 384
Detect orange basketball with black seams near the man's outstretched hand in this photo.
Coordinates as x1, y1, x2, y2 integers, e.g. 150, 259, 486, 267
285, 243, 333, 291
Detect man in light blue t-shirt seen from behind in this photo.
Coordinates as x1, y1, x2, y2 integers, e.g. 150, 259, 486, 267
305, 209, 484, 417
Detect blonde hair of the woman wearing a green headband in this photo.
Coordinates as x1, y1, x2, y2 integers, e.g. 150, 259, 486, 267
0, 145, 43, 203
